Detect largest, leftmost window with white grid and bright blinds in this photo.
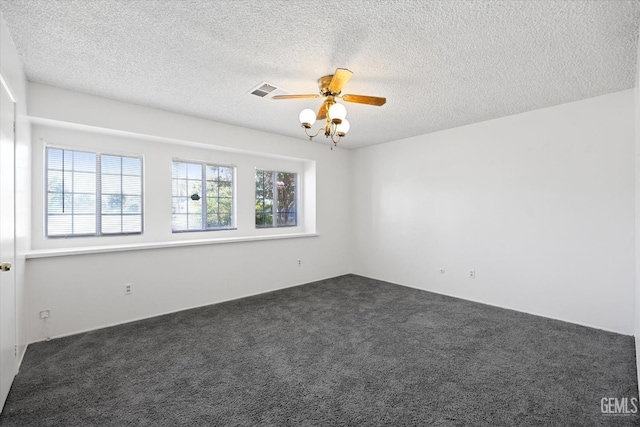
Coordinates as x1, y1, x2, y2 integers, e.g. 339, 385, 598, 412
45, 147, 142, 237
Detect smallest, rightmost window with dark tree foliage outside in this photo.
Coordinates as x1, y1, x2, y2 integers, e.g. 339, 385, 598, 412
256, 169, 298, 228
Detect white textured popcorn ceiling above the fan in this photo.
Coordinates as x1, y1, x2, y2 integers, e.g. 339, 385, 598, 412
0, 0, 640, 148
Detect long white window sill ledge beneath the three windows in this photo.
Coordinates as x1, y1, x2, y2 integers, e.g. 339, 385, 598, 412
25, 233, 319, 259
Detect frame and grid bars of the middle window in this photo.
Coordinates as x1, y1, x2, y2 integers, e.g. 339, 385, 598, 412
170, 158, 238, 234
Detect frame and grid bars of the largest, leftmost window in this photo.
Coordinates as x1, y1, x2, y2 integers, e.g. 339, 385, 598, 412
43, 144, 145, 239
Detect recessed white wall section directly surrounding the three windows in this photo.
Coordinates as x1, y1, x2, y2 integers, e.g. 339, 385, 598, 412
31, 125, 316, 250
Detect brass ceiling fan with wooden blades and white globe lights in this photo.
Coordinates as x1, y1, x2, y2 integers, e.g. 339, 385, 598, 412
273, 68, 387, 149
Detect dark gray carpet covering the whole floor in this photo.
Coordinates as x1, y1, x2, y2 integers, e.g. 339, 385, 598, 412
0, 275, 639, 426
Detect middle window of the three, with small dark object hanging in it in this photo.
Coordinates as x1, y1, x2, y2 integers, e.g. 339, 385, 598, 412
171, 161, 235, 232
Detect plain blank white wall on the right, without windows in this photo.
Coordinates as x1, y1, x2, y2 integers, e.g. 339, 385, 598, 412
351, 90, 635, 334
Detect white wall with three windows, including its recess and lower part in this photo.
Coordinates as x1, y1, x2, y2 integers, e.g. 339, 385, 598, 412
26, 83, 350, 342
